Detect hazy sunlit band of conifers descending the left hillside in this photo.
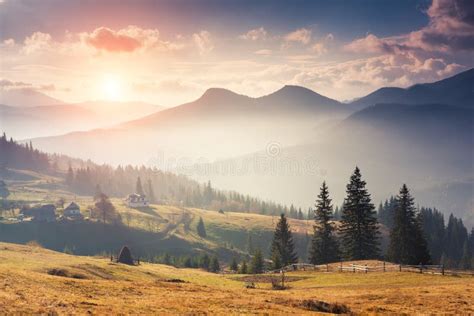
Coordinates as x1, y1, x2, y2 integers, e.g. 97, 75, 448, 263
0, 133, 304, 219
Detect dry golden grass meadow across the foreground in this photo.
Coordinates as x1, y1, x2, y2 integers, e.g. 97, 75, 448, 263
0, 243, 474, 314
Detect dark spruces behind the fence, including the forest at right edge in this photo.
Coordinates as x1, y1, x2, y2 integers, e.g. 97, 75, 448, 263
271, 167, 474, 269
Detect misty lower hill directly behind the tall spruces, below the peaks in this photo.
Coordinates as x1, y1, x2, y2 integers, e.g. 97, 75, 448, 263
189, 104, 474, 225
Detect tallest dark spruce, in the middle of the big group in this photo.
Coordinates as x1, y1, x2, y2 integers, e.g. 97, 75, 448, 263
340, 167, 380, 260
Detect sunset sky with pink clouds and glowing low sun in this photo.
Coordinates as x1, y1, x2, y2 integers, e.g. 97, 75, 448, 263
0, 0, 474, 106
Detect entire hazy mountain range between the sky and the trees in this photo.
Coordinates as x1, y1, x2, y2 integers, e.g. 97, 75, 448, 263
2, 69, 474, 225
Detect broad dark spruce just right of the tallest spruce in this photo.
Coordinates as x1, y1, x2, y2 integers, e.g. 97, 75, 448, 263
387, 184, 429, 264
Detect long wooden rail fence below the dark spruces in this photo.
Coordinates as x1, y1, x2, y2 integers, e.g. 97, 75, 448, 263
266, 262, 474, 276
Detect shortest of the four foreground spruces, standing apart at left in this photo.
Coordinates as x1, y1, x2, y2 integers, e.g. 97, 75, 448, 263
271, 214, 298, 269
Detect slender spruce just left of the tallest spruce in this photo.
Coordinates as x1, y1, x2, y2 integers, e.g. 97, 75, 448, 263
309, 182, 339, 264
